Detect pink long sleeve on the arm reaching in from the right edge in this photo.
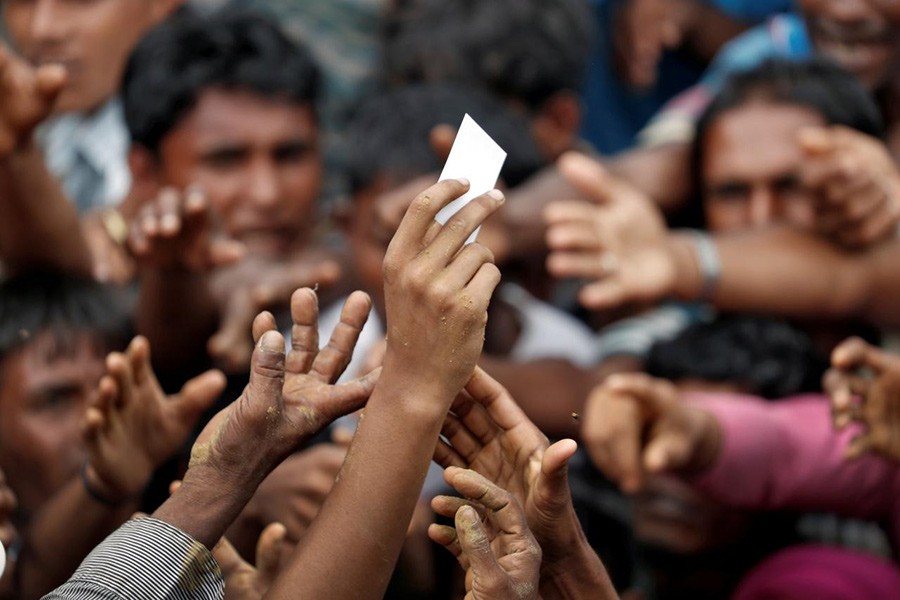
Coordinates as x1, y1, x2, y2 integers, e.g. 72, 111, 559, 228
688, 394, 900, 548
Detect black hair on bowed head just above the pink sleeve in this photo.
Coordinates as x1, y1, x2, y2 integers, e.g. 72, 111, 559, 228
646, 316, 828, 399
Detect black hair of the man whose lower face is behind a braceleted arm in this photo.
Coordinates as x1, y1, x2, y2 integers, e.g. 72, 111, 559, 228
691, 58, 885, 213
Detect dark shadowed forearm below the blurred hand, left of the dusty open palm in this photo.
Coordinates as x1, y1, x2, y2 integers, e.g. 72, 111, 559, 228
136, 269, 221, 373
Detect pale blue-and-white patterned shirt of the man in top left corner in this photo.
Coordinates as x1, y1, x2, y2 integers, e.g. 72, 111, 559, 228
38, 99, 131, 213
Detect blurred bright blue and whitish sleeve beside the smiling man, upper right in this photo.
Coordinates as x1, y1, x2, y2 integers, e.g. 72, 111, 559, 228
638, 14, 813, 146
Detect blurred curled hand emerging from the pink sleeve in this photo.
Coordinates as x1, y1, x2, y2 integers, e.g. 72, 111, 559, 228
581, 373, 720, 493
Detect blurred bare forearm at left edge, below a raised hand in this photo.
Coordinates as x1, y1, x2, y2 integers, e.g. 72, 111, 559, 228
0, 142, 93, 277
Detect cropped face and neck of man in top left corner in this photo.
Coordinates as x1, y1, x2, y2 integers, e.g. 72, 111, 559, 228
2, 0, 180, 112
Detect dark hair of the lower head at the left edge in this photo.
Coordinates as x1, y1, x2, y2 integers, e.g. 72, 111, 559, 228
0, 272, 132, 374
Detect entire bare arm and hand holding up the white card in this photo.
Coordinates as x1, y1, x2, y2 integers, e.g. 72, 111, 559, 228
267, 180, 502, 600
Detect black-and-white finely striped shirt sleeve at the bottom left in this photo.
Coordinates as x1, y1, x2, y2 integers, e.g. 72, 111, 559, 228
44, 517, 225, 600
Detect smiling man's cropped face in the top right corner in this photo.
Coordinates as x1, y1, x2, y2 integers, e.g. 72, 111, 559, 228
799, 0, 900, 89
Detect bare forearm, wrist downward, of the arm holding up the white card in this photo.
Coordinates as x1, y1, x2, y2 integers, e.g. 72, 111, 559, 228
266, 378, 452, 600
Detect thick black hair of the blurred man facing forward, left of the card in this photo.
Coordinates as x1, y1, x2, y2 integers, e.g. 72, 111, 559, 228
122, 10, 319, 153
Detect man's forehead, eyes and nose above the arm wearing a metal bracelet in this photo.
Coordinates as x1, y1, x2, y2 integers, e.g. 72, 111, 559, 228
702, 102, 825, 232
